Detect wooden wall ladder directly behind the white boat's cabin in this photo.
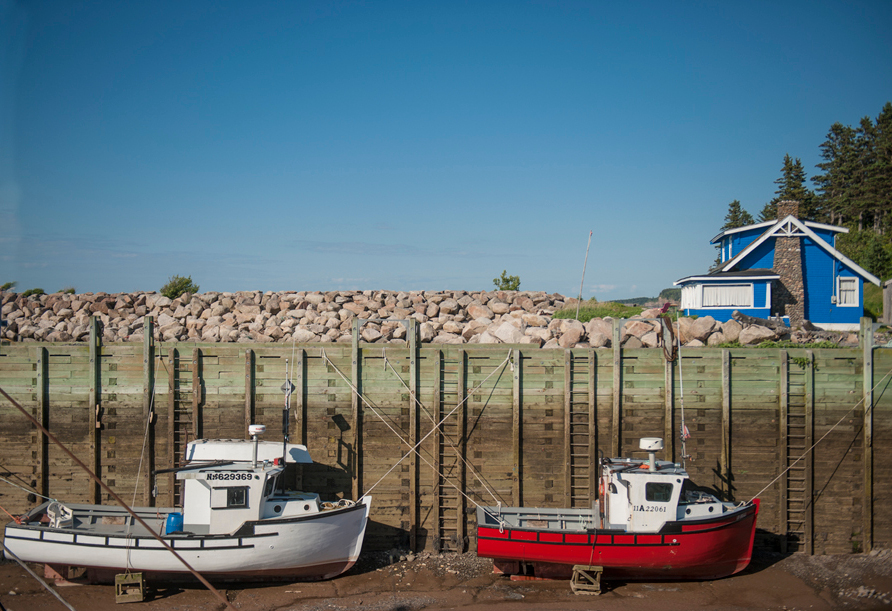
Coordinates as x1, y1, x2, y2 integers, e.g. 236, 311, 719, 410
167, 348, 201, 507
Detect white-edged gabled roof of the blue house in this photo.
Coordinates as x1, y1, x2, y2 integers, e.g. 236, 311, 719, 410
673, 215, 880, 286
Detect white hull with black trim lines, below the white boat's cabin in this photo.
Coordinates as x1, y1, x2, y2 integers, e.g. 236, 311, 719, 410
5, 499, 371, 581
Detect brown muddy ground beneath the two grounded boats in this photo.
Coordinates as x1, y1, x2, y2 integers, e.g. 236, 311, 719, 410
0, 550, 892, 611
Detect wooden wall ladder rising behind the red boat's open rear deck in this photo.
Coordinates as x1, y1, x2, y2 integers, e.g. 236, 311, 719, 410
564, 350, 598, 507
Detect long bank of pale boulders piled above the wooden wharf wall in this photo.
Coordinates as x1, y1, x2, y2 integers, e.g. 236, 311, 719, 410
2, 291, 856, 348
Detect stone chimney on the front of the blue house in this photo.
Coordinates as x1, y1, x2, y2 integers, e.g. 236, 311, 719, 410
771, 201, 805, 328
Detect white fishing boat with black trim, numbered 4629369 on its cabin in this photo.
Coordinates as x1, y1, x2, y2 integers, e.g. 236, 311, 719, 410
5, 425, 372, 581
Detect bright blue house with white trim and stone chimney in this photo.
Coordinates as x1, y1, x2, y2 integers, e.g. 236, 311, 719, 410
675, 201, 880, 330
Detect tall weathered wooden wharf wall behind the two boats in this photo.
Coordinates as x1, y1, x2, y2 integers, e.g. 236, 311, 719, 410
0, 324, 892, 554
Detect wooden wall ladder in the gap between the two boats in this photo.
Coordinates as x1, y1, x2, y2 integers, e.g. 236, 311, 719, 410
431, 350, 466, 554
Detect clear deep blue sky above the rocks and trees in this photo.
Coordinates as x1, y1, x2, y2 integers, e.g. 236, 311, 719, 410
0, 0, 892, 299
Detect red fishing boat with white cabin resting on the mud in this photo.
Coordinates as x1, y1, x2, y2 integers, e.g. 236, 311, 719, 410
477, 437, 759, 580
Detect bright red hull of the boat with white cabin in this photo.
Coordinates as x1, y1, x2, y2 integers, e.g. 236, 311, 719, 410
477, 499, 759, 579
